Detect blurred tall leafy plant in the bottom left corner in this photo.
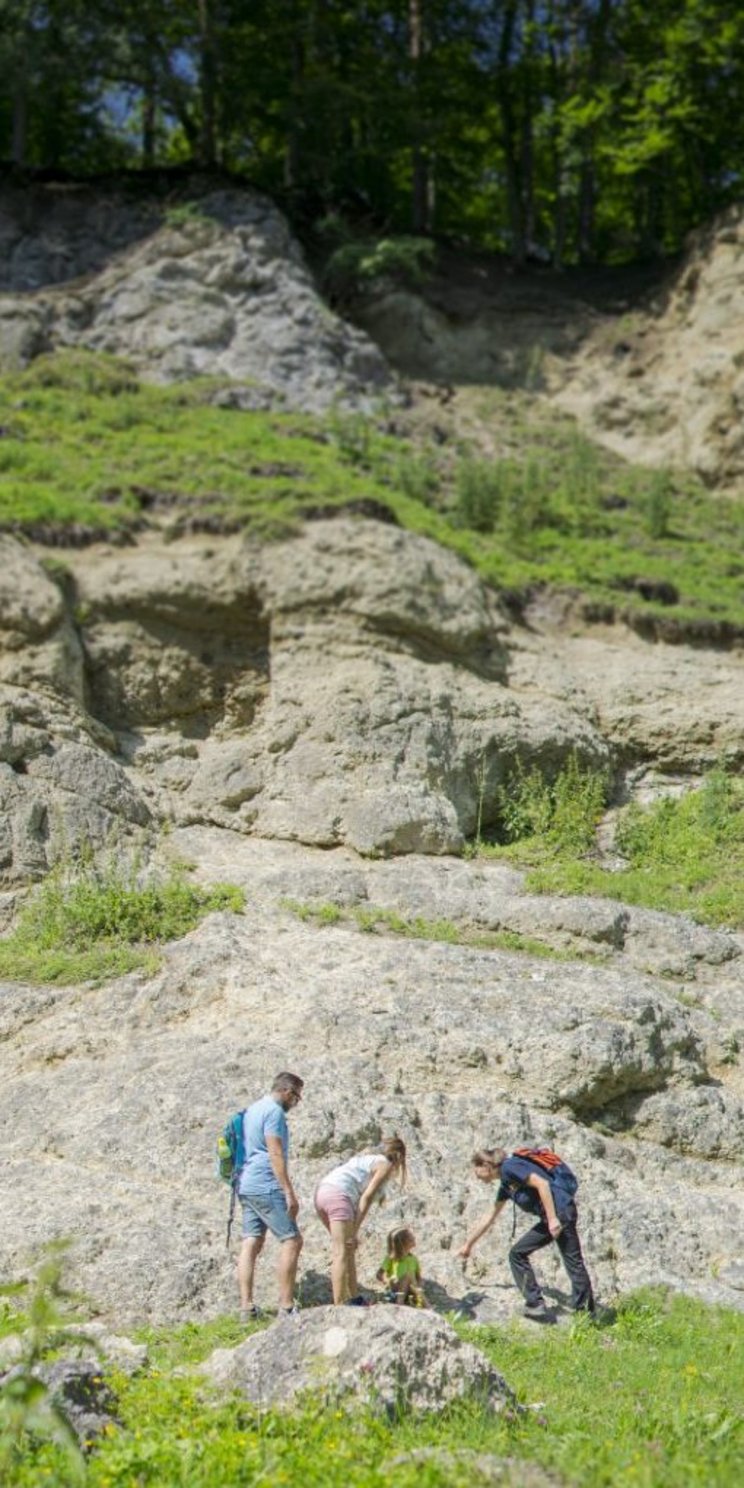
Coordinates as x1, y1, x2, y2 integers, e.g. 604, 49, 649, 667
0, 1241, 87, 1482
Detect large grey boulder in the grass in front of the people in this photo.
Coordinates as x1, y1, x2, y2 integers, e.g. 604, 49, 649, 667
204, 1306, 515, 1417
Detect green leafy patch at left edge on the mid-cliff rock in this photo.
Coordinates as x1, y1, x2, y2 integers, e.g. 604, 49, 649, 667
0, 853, 244, 982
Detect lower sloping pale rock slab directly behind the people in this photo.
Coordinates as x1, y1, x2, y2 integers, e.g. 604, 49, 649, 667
0, 827, 744, 1329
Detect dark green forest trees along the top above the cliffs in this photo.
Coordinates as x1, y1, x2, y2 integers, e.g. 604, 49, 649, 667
0, 0, 744, 265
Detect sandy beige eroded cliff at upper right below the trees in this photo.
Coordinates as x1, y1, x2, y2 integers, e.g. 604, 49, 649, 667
352, 208, 744, 488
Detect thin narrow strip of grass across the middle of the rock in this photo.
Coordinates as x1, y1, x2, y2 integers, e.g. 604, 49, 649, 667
283, 899, 601, 961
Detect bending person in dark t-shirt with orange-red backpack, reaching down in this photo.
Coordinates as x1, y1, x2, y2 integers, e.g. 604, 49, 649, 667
457, 1147, 594, 1318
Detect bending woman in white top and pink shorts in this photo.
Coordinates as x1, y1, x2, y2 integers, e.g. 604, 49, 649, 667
315, 1137, 406, 1306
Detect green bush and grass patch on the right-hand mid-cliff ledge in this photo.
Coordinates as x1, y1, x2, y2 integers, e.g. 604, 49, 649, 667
476, 759, 744, 929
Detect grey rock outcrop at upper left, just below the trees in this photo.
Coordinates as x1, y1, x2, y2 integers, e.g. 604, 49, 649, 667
0, 186, 390, 409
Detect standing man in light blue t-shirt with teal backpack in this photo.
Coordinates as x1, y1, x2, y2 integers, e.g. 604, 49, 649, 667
238, 1070, 304, 1323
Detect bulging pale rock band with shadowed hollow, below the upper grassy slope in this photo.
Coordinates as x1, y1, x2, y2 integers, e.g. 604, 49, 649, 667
7, 516, 744, 874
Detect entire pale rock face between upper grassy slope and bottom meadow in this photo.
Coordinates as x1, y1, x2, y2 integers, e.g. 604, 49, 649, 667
0, 518, 744, 1318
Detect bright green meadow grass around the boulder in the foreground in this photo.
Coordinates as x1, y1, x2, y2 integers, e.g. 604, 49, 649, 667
4, 1289, 744, 1488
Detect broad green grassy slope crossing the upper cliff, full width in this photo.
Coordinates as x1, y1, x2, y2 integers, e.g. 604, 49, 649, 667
0, 351, 744, 628
